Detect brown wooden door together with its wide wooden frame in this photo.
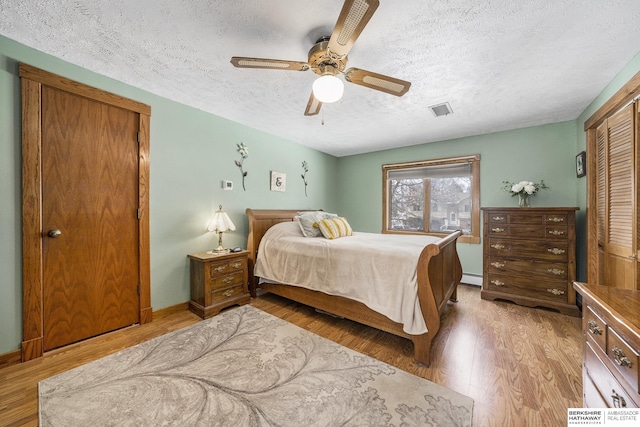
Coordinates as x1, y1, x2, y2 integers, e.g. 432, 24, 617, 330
20, 64, 153, 361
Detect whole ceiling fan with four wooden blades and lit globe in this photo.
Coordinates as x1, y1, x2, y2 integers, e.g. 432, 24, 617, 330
231, 0, 411, 116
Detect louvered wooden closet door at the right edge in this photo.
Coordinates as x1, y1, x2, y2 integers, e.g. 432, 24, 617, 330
598, 105, 637, 289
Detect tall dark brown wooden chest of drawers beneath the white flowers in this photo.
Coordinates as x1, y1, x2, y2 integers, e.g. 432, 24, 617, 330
481, 207, 580, 316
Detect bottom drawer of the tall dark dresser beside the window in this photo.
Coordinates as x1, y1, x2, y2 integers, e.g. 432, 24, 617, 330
482, 273, 568, 302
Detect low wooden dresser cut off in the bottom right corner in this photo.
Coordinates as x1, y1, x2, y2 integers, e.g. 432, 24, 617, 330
574, 282, 640, 408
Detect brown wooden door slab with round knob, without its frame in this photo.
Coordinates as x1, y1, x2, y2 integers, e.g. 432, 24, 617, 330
42, 87, 140, 351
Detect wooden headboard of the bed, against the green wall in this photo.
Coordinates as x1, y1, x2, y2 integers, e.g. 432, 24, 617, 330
246, 208, 321, 298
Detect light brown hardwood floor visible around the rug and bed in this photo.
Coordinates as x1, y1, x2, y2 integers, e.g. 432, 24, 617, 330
0, 285, 582, 427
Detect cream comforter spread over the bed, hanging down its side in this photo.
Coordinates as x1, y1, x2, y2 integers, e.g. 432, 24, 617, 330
254, 222, 439, 335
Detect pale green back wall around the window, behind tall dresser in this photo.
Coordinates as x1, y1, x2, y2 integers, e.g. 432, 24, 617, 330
338, 121, 578, 275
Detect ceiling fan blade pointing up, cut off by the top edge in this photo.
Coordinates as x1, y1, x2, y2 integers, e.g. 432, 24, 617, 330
328, 0, 380, 56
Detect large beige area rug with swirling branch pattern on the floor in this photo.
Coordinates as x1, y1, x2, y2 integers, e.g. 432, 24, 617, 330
38, 305, 473, 427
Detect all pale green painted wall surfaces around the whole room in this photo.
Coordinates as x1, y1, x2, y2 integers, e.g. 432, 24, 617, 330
0, 36, 640, 354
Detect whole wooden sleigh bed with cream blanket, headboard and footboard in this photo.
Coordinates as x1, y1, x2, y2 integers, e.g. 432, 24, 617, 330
247, 209, 462, 365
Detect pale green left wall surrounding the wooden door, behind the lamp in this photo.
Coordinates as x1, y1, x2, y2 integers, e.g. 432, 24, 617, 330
0, 36, 338, 354
